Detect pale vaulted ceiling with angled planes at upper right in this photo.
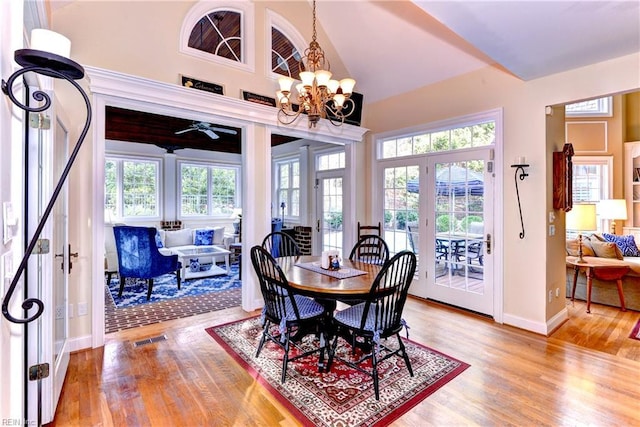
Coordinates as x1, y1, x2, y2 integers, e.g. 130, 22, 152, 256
317, 0, 640, 104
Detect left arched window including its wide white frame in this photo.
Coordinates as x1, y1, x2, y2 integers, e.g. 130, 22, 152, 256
180, 1, 255, 72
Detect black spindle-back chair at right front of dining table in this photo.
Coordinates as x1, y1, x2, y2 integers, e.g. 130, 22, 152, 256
327, 251, 416, 400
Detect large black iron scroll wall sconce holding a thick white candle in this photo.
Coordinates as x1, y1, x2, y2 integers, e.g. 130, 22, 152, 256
2, 29, 91, 323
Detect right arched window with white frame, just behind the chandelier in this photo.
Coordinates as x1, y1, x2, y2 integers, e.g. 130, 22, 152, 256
267, 9, 306, 79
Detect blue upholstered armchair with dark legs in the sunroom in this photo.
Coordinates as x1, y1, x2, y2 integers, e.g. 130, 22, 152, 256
113, 225, 181, 299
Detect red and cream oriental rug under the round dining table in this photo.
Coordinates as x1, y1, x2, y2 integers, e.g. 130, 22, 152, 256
206, 317, 469, 427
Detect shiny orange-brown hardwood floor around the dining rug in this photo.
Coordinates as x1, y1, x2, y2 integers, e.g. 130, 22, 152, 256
51, 299, 640, 426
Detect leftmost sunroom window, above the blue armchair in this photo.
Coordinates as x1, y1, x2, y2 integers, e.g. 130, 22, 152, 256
105, 157, 161, 221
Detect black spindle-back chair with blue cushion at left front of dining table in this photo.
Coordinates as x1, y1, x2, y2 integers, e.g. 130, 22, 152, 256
251, 246, 328, 383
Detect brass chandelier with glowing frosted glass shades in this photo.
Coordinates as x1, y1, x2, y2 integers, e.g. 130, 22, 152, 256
276, 0, 356, 128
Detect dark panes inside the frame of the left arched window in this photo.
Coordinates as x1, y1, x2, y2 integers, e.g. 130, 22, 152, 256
188, 10, 242, 62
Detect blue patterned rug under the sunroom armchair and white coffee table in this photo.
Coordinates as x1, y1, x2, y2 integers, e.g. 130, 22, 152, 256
109, 264, 242, 308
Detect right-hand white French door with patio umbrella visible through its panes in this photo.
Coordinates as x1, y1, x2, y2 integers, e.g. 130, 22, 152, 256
428, 148, 494, 316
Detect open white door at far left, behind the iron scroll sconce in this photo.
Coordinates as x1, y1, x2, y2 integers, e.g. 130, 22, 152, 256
25, 95, 70, 425
